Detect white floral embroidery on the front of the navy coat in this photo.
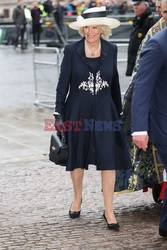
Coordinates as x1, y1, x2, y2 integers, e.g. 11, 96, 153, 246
78, 71, 109, 95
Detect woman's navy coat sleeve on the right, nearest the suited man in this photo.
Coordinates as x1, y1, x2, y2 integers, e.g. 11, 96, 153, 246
111, 47, 122, 116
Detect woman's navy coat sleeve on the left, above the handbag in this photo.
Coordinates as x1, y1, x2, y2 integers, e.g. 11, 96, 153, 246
55, 46, 72, 116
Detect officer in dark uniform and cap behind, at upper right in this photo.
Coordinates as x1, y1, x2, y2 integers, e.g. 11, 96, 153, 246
126, 0, 155, 76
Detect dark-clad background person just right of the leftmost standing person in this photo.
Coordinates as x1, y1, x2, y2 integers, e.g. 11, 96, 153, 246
31, 2, 42, 46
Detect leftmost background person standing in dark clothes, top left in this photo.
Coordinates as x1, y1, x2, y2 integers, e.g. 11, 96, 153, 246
13, 0, 27, 50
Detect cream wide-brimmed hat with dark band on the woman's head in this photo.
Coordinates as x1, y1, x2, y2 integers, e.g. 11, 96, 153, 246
69, 6, 120, 30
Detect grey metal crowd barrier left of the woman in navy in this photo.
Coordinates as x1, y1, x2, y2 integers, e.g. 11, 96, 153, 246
33, 47, 60, 108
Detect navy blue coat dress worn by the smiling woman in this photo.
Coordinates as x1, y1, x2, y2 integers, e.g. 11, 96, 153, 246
55, 38, 130, 171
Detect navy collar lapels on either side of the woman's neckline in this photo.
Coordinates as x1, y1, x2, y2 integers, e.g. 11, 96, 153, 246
75, 38, 108, 64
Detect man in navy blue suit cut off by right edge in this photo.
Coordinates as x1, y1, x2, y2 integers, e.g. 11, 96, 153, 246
132, 27, 167, 237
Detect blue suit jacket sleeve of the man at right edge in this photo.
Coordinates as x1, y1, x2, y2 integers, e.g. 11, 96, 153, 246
131, 39, 163, 132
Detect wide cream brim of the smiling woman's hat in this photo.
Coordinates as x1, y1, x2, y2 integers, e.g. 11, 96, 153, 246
69, 17, 120, 30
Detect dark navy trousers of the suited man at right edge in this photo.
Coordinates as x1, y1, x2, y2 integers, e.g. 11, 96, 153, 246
156, 145, 167, 231
